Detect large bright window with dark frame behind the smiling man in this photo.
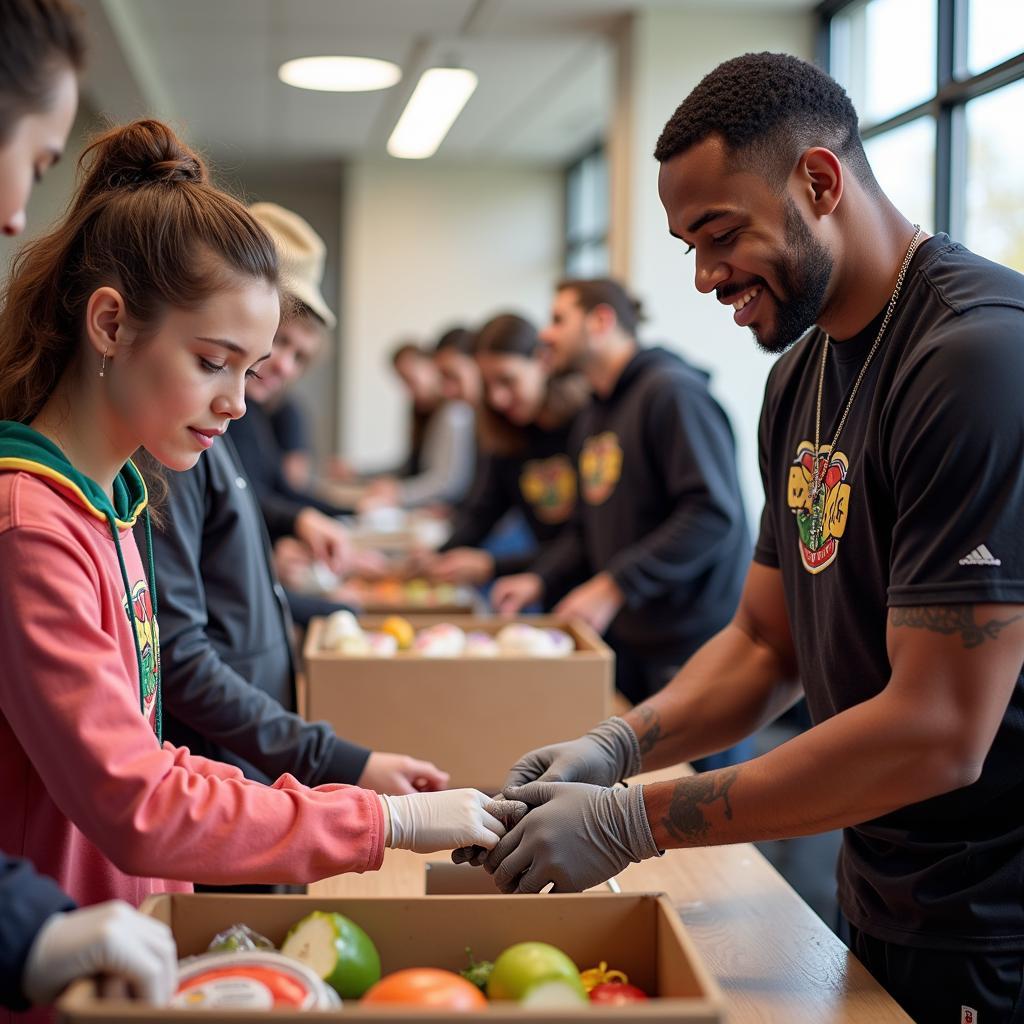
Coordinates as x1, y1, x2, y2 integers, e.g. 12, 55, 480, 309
819, 0, 1024, 271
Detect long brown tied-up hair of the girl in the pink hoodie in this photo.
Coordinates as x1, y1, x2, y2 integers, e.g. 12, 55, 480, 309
0, 121, 278, 423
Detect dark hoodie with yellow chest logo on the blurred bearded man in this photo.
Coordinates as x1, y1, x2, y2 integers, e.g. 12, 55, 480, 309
534, 348, 751, 665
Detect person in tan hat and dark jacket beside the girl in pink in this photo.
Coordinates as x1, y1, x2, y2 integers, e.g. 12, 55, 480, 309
146, 204, 447, 794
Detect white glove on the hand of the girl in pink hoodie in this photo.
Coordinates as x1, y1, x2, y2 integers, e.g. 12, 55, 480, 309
380, 790, 505, 853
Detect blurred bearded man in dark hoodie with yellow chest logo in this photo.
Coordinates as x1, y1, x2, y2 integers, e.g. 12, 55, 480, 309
492, 279, 751, 768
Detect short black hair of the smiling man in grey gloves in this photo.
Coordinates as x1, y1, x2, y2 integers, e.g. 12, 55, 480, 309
654, 53, 878, 191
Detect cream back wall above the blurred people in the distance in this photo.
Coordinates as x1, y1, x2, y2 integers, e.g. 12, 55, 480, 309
339, 161, 562, 467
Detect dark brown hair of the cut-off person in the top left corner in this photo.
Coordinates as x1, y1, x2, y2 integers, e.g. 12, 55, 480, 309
0, 0, 85, 145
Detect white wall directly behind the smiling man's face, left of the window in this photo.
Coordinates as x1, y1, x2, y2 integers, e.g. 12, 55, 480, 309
612, 9, 814, 524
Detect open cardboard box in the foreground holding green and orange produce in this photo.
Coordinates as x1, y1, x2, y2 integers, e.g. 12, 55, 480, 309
58, 893, 724, 1024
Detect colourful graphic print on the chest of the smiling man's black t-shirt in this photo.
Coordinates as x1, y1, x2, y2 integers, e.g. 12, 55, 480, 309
786, 441, 850, 573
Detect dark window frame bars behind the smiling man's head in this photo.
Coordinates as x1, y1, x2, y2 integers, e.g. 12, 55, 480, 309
816, 0, 1024, 238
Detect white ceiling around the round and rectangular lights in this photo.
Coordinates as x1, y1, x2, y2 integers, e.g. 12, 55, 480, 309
84, 0, 809, 164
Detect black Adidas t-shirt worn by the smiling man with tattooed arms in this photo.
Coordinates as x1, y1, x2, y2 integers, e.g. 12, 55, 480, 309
755, 234, 1024, 950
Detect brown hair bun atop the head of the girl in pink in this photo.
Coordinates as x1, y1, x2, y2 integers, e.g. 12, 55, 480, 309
80, 120, 209, 200
